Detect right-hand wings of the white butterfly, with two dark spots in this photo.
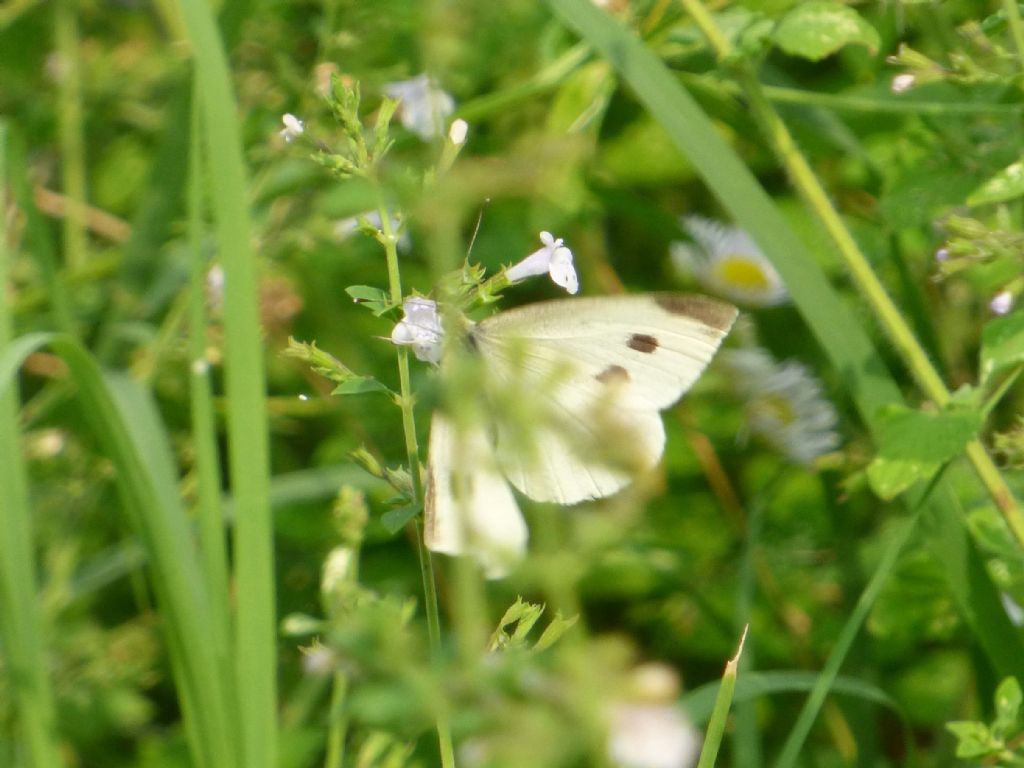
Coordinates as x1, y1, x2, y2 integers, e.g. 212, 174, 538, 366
472, 294, 736, 504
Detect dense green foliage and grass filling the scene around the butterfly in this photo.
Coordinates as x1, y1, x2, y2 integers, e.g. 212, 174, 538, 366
0, 0, 1024, 768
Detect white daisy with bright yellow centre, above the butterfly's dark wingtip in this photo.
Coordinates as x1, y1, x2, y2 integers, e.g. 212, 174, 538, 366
672, 216, 790, 307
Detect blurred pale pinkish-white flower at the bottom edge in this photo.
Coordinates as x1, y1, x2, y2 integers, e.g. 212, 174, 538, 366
608, 664, 700, 768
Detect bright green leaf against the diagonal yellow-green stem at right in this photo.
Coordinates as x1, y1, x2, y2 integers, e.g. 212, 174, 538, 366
867, 404, 982, 500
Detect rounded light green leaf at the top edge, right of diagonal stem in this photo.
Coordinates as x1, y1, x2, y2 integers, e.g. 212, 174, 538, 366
774, 0, 881, 61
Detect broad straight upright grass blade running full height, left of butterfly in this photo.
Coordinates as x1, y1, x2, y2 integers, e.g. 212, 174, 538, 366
172, 0, 278, 757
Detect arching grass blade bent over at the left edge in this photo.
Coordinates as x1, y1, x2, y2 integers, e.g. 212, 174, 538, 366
0, 334, 239, 768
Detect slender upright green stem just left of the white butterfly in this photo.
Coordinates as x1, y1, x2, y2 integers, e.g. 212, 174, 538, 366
377, 200, 455, 768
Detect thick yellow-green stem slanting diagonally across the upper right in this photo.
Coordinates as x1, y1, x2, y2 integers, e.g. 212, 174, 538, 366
680, 0, 1024, 547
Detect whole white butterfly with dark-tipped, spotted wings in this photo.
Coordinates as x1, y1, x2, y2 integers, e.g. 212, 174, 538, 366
424, 293, 736, 578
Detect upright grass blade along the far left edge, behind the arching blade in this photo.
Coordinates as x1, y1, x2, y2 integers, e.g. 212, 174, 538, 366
0, 122, 60, 768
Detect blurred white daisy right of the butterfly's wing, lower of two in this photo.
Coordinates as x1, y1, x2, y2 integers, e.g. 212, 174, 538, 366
720, 349, 840, 465
